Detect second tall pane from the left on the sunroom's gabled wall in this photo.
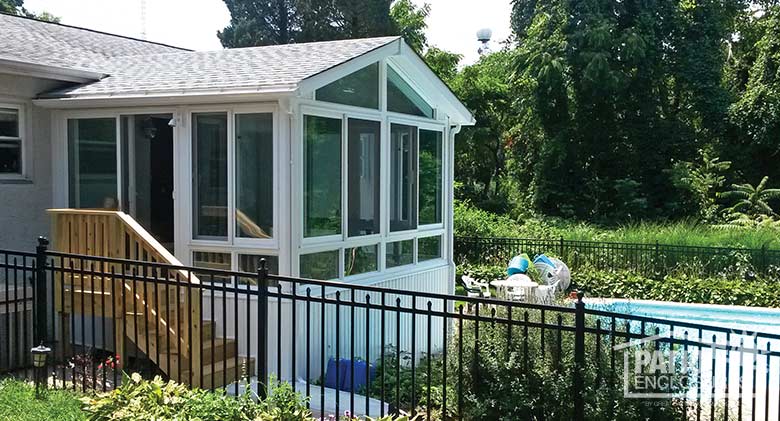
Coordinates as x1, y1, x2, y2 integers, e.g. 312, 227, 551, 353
347, 119, 380, 237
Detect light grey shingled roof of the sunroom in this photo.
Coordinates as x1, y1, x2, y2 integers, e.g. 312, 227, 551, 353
44, 37, 399, 98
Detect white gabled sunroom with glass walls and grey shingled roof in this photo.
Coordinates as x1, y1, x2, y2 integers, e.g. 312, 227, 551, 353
41, 37, 473, 293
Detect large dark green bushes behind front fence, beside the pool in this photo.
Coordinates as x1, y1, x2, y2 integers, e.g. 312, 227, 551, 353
371, 306, 679, 421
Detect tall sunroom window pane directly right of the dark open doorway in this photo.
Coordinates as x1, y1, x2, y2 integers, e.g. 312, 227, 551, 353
192, 113, 228, 238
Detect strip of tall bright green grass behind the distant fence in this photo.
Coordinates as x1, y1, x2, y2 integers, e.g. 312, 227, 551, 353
455, 202, 780, 249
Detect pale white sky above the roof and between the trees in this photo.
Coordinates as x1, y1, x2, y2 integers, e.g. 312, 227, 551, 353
24, 0, 511, 64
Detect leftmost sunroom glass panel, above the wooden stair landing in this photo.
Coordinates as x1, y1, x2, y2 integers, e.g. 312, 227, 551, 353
68, 118, 119, 209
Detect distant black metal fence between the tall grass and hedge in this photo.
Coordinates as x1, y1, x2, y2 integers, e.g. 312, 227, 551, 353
455, 237, 780, 279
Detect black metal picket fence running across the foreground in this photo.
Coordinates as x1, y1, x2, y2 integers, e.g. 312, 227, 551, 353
0, 238, 780, 420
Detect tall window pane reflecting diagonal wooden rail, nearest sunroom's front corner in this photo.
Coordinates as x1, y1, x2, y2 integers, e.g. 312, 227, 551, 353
236, 113, 274, 238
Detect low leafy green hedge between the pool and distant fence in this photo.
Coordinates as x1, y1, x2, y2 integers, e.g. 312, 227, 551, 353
572, 268, 780, 307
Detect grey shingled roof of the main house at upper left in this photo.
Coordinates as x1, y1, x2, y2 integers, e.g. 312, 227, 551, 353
0, 13, 189, 73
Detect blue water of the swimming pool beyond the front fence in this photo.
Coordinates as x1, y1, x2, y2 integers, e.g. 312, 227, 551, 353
585, 298, 780, 335
